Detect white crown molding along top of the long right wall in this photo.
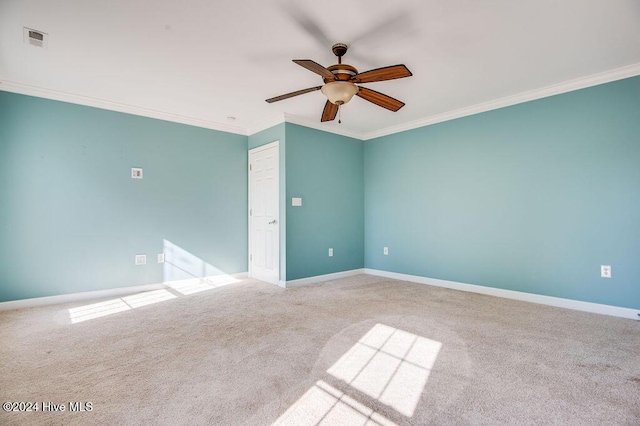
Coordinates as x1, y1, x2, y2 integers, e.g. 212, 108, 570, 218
361, 64, 640, 140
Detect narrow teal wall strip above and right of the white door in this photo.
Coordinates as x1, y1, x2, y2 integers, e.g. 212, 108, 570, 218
249, 123, 287, 281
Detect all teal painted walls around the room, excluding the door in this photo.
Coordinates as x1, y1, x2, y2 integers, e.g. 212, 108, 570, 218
0, 77, 640, 308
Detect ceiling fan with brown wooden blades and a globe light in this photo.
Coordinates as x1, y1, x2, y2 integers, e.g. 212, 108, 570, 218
267, 43, 413, 122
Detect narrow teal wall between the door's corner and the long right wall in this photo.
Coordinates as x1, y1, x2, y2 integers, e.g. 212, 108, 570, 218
286, 123, 364, 280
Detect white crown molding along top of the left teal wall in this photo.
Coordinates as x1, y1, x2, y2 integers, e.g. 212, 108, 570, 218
0, 80, 247, 136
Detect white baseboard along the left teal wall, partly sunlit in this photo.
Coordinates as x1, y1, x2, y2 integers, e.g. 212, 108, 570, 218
0, 272, 247, 311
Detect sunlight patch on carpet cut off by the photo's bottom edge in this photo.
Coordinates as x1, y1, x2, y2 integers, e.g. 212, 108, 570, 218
273, 380, 395, 426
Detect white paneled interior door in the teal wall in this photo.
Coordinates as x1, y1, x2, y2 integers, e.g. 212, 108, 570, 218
249, 142, 280, 285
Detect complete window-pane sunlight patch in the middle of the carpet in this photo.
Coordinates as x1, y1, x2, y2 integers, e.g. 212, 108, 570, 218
327, 324, 442, 417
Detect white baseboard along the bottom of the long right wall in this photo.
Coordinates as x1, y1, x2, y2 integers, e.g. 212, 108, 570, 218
364, 268, 640, 320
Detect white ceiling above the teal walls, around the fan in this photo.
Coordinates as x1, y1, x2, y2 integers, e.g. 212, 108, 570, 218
0, 0, 640, 139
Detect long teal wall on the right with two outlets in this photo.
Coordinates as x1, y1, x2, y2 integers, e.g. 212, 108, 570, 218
365, 77, 640, 308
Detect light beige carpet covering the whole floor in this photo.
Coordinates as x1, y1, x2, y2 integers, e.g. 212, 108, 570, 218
0, 275, 640, 425
